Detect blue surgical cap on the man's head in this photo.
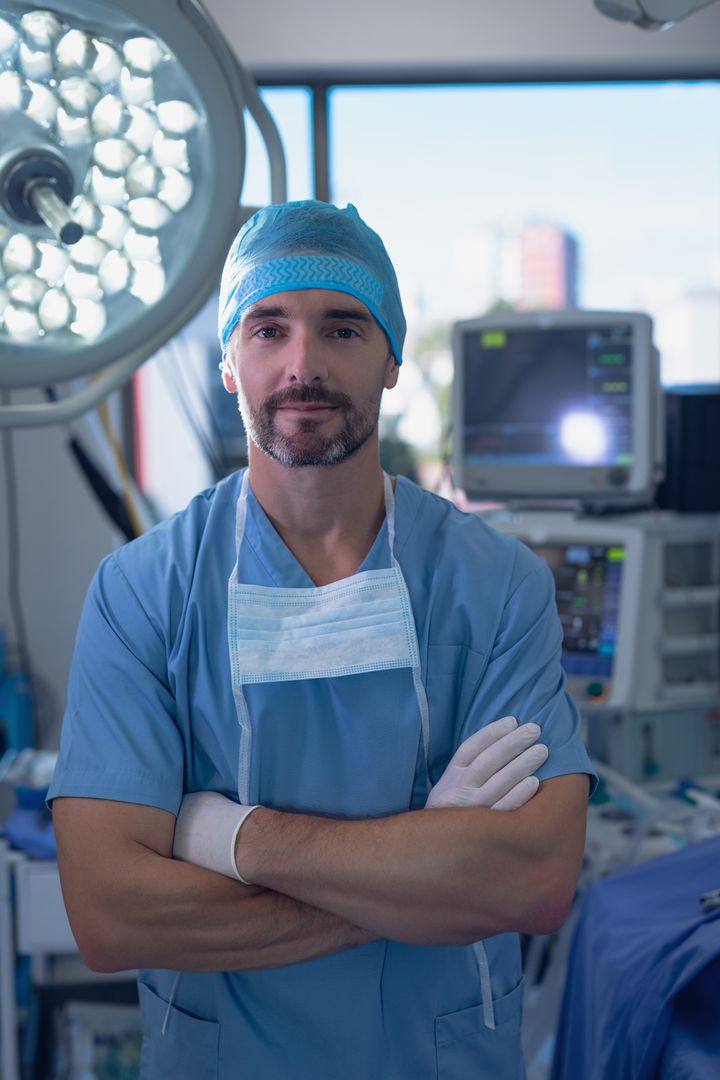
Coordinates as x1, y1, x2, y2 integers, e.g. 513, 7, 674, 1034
218, 199, 406, 364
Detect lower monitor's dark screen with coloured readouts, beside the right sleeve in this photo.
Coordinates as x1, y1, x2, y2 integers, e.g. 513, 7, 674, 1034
532, 542, 626, 678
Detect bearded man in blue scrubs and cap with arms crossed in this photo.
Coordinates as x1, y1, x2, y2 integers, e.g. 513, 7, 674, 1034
50, 202, 592, 1080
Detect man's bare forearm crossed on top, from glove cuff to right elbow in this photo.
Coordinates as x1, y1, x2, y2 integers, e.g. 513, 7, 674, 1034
236, 778, 586, 945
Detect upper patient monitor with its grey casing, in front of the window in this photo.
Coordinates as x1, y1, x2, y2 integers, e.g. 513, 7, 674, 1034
453, 311, 660, 505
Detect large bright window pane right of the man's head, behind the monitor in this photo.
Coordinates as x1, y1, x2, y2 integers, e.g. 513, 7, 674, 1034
329, 82, 720, 470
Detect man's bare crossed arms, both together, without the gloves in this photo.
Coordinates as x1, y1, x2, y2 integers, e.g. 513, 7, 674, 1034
53, 774, 587, 971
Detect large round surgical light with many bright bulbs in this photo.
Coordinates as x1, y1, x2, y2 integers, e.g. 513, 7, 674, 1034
0, 0, 286, 427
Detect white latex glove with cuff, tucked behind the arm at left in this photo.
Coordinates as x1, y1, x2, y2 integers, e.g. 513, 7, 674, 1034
173, 792, 262, 885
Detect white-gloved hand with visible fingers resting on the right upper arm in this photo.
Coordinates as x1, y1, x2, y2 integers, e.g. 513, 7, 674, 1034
425, 716, 549, 810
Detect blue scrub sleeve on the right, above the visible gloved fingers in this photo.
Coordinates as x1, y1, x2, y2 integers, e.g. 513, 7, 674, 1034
460, 562, 597, 791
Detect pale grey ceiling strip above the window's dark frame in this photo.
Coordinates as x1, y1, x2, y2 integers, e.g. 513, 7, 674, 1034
205, 0, 720, 79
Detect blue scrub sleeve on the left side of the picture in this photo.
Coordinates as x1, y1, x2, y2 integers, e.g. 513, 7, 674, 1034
47, 555, 184, 813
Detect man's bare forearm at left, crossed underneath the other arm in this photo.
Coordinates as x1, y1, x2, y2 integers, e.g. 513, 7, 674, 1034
58, 850, 371, 971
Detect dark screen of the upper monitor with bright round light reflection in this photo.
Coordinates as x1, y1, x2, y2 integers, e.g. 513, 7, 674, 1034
463, 322, 634, 465
